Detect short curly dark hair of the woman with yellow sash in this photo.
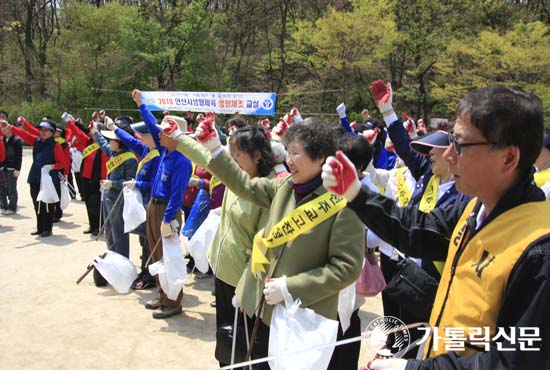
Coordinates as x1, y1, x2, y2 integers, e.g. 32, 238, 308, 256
282, 118, 337, 160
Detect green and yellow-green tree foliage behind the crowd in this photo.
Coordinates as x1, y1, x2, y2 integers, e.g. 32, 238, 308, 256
0, 0, 550, 122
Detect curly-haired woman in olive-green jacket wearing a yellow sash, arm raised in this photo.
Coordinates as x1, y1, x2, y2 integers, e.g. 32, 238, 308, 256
178, 114, 365, 366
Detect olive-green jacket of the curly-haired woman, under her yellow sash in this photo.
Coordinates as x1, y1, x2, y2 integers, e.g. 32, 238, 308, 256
207, 151, 365, 325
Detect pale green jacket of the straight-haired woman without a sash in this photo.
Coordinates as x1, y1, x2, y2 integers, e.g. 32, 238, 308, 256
178, 137, 273, 287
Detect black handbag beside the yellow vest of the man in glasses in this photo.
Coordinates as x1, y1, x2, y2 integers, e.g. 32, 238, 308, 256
384, 258, 439, 322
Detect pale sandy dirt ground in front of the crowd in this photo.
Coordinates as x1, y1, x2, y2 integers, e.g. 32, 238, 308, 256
0, 149, 382, 370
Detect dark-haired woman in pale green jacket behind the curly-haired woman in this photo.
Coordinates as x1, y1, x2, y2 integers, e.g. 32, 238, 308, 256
181, 127, 275, 367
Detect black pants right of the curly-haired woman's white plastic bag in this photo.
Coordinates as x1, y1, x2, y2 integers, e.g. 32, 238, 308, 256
328, 309, 361, 370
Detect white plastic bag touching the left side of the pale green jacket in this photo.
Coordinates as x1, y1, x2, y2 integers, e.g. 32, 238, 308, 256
187, 211, 221, 274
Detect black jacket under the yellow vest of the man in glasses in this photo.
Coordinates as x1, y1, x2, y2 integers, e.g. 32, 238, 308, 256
348, 174, 550, 370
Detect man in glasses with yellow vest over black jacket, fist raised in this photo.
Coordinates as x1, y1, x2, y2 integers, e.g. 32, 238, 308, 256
323, 83, 550, 370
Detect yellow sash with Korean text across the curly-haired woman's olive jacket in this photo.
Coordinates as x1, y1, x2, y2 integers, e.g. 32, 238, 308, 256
250, 192, 346, 278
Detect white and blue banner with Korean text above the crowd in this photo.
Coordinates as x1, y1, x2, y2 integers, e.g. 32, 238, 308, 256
141, 91, 277, 116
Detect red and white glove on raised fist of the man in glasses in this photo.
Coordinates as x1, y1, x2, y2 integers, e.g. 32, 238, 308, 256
321, 150, 361, 201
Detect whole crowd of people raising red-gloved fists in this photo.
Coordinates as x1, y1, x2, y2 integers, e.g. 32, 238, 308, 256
0, 81, 550, 370
